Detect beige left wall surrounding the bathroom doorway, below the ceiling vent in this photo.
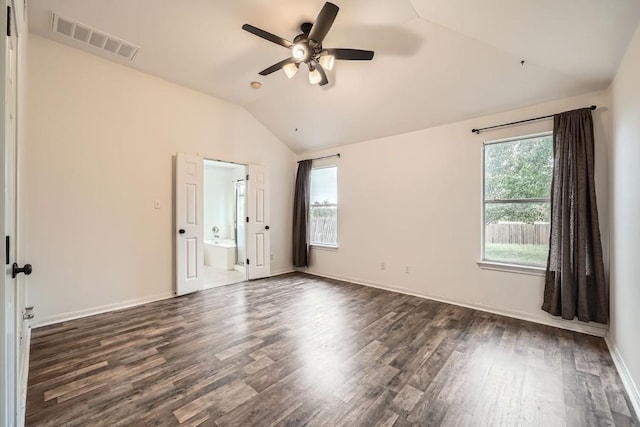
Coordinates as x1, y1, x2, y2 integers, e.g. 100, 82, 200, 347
23, 35, 295, 325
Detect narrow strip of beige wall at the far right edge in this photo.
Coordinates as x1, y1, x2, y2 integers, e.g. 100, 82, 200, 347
608, 22, 640, 414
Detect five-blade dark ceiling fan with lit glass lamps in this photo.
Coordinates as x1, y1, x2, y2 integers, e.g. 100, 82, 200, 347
242, 2, 374, 86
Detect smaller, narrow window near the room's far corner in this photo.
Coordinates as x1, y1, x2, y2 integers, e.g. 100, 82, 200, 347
309, 166, 338, 247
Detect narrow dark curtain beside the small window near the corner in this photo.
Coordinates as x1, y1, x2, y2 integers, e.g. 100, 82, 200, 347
293, 160, 312, 267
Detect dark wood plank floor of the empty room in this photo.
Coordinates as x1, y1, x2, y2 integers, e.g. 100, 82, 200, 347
27, 274, 640, 427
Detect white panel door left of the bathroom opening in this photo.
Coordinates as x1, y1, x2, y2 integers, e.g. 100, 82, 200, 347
174, 153, 204, 295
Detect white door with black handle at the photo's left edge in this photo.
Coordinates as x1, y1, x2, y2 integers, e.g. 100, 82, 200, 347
0, 2, 19, 426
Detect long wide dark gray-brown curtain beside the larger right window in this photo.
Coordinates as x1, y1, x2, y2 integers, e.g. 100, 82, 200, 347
542, 108, 609, 324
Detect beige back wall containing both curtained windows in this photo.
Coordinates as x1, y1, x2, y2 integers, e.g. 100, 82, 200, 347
299, 92, 608, 334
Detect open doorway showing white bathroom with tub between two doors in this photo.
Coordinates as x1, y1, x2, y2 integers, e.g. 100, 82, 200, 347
203, 160, 247, 289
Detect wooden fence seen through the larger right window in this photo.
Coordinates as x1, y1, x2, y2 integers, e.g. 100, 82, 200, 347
484, 222, 551, 245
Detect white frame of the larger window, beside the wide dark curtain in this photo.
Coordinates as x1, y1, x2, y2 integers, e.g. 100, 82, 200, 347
477, 131, 553, 276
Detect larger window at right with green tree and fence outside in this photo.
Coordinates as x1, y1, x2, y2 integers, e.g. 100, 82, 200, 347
482, 134, 553, 267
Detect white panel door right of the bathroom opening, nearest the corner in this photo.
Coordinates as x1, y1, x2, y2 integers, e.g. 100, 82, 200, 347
246, 165, 271, 280
